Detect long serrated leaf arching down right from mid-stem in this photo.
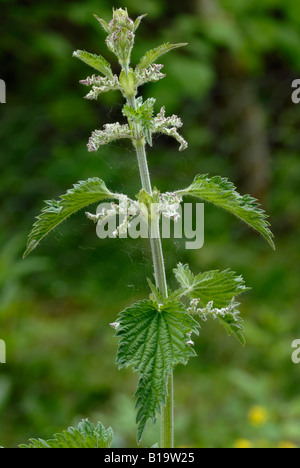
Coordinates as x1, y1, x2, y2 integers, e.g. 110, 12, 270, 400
176, 174, 275, 250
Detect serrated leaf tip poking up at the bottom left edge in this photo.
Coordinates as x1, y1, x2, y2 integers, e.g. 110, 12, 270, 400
19, 419, 113, 448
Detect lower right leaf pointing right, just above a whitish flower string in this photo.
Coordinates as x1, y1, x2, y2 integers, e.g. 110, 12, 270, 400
174, 263, 250, 307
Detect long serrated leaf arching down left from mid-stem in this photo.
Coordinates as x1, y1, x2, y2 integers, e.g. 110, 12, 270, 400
24, 178, 114, 257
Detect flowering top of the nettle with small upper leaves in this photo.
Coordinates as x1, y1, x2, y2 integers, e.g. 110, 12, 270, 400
73, 8, 188, 155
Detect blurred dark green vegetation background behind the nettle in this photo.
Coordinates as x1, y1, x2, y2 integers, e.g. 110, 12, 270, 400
0, 0, 300, 447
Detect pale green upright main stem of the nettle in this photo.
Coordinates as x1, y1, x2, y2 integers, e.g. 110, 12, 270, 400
128, 94, 174, 448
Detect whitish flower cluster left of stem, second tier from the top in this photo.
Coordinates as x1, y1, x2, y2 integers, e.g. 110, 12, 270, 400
87, 122, 132, 151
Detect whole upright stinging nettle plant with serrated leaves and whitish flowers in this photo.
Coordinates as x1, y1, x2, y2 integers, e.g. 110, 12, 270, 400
25, 9, 274, 448
